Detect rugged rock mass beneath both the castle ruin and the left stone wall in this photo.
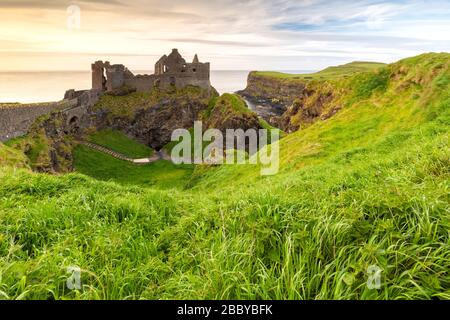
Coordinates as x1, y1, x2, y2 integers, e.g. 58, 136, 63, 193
5, 88, 217, 173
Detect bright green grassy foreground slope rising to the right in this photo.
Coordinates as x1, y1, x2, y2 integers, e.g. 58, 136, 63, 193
0, 54, 450, 299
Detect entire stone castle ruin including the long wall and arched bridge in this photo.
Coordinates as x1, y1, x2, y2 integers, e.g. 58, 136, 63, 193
0, 49, 211, 141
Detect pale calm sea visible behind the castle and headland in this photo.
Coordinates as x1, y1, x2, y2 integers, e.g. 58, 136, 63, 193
0, 70, 306, 103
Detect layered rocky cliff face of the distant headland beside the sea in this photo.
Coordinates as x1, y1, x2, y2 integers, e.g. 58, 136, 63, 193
239, 72, 344, 132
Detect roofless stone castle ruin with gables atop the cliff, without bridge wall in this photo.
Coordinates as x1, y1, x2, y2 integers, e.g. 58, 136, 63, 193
92, 49, 211, 92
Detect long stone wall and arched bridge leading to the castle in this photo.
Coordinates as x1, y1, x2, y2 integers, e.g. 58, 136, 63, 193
0, 90, 102, 141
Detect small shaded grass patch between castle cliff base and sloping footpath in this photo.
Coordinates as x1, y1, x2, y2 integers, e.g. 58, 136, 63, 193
88, 129, 153, 159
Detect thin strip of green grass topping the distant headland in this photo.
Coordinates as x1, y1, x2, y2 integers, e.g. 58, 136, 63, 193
256, 61, 386, 80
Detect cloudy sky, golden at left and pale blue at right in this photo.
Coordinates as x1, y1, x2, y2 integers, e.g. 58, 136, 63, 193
0, 0, 450, 72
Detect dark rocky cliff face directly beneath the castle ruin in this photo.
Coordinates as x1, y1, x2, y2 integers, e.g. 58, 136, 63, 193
92, 87, 217, 150
